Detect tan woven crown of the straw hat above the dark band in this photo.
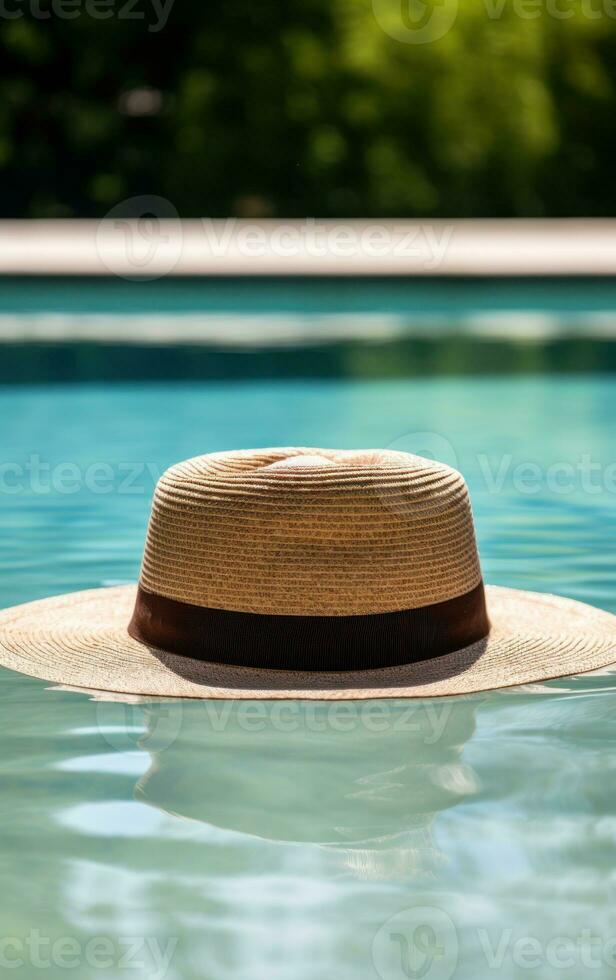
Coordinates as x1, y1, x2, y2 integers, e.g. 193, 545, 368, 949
141, 448, 481, 616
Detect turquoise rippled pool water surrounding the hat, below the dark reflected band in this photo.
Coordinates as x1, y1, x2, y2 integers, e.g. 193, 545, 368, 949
0, 374, 616, 980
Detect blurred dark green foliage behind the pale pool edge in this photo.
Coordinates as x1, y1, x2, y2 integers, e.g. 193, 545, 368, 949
0, 0, 616, 217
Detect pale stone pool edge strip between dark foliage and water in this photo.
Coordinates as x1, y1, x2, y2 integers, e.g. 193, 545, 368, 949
0, 215, 616, 280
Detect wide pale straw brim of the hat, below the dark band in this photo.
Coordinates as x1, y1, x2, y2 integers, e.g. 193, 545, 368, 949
0, 585, 616, 700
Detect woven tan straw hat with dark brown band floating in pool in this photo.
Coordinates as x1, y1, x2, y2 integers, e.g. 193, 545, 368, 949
0, 448, 616, 699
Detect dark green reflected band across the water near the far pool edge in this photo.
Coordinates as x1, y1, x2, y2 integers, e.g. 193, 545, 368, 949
6, 329, 616, 385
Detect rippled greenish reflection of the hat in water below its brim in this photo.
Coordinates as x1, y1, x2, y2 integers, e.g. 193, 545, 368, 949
80, 691, 480, 878
